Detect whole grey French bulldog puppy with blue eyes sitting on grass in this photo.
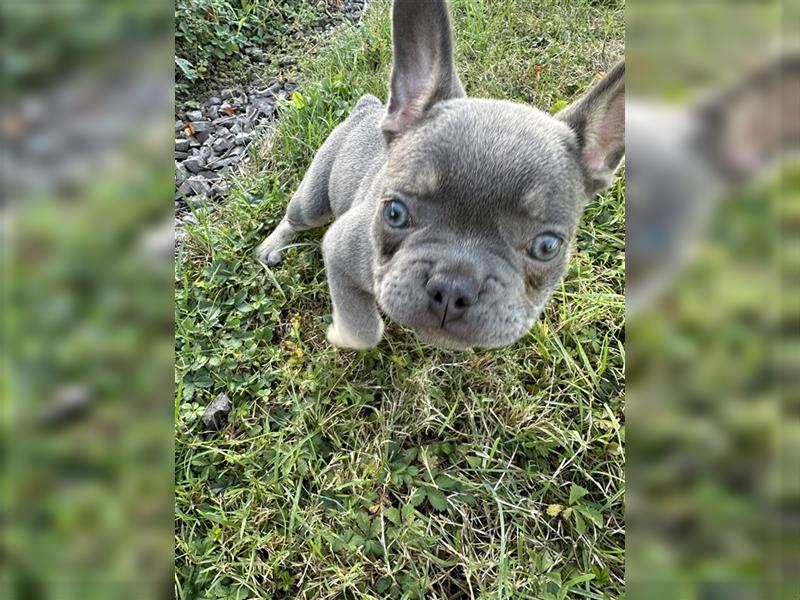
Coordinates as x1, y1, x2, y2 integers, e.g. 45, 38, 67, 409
258, 0, 625, 349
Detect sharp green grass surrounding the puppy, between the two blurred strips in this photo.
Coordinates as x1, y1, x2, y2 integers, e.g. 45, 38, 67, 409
175, 0, 625, 600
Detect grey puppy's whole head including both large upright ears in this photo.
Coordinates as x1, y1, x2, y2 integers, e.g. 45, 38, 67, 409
373, 0, 624, 348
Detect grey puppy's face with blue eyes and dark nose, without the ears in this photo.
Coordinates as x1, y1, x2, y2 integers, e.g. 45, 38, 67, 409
373, 99, 585, 348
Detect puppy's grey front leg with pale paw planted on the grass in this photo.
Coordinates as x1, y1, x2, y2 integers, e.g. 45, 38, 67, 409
322, 223, 383, 350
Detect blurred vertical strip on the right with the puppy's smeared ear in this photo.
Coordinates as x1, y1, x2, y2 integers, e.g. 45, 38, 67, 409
625, 0, 800, 600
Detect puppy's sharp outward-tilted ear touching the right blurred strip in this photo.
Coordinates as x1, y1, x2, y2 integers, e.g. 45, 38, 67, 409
556, 61, 625, 195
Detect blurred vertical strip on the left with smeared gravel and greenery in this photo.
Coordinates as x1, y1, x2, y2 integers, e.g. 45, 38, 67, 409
0, 0, 174, 599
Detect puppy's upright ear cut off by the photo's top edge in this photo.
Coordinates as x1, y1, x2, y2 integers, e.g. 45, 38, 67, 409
382, 0, 466, 141
